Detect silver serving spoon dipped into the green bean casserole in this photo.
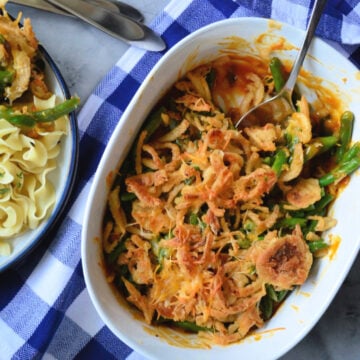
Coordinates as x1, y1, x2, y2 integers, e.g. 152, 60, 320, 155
235, 0, 326, 128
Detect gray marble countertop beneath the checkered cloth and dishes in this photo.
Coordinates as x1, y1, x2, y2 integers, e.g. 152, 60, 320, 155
7, 0, 360, 360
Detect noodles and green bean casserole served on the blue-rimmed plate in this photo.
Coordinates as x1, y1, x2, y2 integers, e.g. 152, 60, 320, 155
0, 1, 79, 256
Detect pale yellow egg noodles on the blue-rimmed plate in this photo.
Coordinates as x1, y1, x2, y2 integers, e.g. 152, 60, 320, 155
0, 96, 68, 238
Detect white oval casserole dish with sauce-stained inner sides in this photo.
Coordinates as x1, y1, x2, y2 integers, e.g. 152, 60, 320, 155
82, 18, 360, 360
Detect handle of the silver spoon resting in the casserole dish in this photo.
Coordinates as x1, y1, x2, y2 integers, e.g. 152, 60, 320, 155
283, 0, 327, 92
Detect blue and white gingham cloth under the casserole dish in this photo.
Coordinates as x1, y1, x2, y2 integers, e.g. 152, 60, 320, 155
0, 0, 360, 360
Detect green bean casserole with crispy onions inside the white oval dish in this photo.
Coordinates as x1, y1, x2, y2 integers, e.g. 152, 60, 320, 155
102, 54, 360, 345
